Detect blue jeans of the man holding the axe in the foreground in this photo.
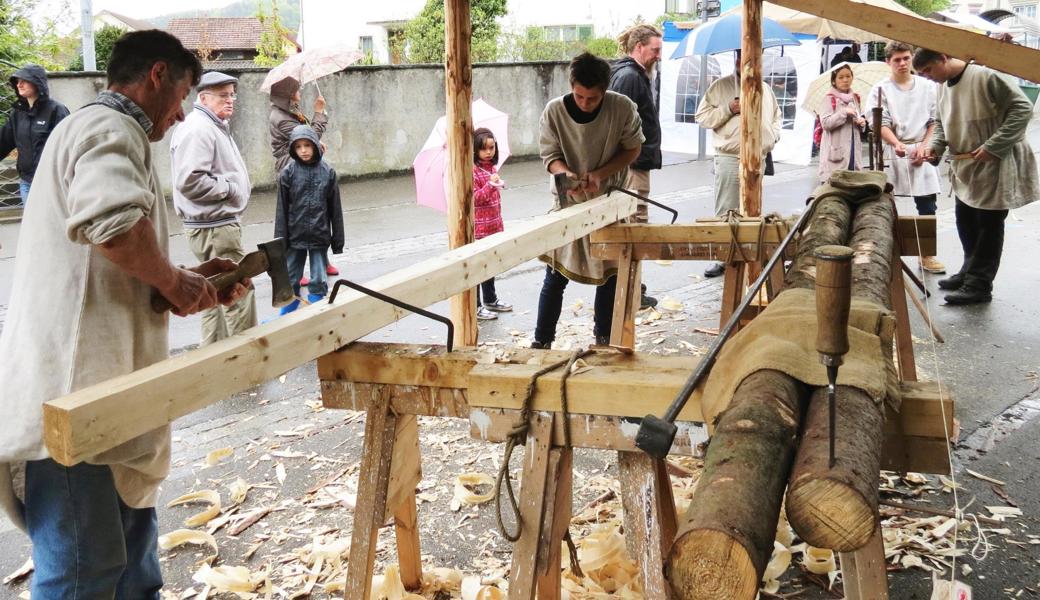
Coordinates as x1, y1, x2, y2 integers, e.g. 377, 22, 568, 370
25, 459, 162, 600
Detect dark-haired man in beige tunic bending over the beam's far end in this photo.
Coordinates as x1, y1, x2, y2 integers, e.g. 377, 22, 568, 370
530, 52, 644, 348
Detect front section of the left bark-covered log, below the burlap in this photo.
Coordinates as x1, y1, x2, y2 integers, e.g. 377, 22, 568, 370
666, 370, 807, 599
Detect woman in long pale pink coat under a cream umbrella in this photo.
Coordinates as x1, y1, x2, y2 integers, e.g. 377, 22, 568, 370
816, 64, 866, 183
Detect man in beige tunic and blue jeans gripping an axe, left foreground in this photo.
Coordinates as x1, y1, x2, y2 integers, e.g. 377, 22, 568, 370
0, 30, 245, 600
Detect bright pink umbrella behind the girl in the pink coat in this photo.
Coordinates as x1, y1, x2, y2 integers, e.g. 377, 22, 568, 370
412, 98, 510, 212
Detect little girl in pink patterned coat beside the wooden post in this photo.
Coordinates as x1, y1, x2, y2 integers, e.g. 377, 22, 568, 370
473, 127, 513, 320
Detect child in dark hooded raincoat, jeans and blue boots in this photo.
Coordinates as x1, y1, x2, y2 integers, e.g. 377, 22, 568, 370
275, 125, 343, 314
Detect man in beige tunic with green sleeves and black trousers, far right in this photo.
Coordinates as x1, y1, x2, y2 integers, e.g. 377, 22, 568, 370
913, 48, 1040, 305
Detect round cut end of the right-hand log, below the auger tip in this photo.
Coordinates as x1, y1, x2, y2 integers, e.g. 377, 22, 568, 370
786, 477, 878, 552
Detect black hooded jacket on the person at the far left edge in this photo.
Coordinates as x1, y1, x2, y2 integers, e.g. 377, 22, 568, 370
0, 64, 69, 182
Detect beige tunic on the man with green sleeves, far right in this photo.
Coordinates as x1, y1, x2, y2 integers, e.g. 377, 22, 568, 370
932, 64, 1040, 210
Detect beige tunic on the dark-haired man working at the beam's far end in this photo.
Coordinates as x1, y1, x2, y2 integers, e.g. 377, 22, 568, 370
539, 92, 644, 285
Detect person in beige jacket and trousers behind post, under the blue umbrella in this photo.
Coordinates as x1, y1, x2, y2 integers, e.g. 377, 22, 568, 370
695, 50, 780, 278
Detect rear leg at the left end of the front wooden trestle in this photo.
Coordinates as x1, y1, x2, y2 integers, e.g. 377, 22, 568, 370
384, 415, 422, 592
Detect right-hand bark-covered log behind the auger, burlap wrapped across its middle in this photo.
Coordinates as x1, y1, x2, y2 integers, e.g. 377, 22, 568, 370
786, 194, 898, 552
